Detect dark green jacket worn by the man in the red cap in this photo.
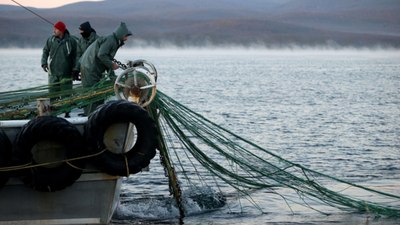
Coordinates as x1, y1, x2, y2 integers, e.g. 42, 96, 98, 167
41, 31, 76, 78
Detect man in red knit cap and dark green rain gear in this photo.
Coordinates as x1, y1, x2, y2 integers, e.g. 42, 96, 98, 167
41, 21, 77, 117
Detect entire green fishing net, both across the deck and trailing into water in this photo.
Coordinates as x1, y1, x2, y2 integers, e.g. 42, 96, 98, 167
0, 79, 400, 217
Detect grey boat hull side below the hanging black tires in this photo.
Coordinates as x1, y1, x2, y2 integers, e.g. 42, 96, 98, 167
0, 172, 121, 225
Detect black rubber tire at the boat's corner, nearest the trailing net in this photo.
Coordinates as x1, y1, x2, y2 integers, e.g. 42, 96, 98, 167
84, 100, 157, 176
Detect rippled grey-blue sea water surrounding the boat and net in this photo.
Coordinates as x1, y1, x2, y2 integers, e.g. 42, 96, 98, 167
0, 49, 400, 225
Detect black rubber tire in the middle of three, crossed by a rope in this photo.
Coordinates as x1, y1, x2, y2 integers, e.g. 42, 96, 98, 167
12, 116, 86, 192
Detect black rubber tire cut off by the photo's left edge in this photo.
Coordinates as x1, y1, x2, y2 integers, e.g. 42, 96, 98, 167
0, 129, 12, 188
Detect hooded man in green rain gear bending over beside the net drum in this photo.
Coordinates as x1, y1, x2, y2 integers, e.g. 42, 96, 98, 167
80, 22, 132, 116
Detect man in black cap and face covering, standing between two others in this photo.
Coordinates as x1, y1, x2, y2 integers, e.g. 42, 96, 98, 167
73, 21, 99, 80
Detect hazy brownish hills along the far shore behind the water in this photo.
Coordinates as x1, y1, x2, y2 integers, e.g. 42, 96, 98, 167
0, 0, 400, 47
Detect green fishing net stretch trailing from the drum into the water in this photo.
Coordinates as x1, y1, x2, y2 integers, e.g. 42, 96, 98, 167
151, 91, 400, 217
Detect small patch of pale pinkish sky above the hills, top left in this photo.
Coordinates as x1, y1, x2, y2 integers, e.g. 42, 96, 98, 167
0, 0, 100, 8
